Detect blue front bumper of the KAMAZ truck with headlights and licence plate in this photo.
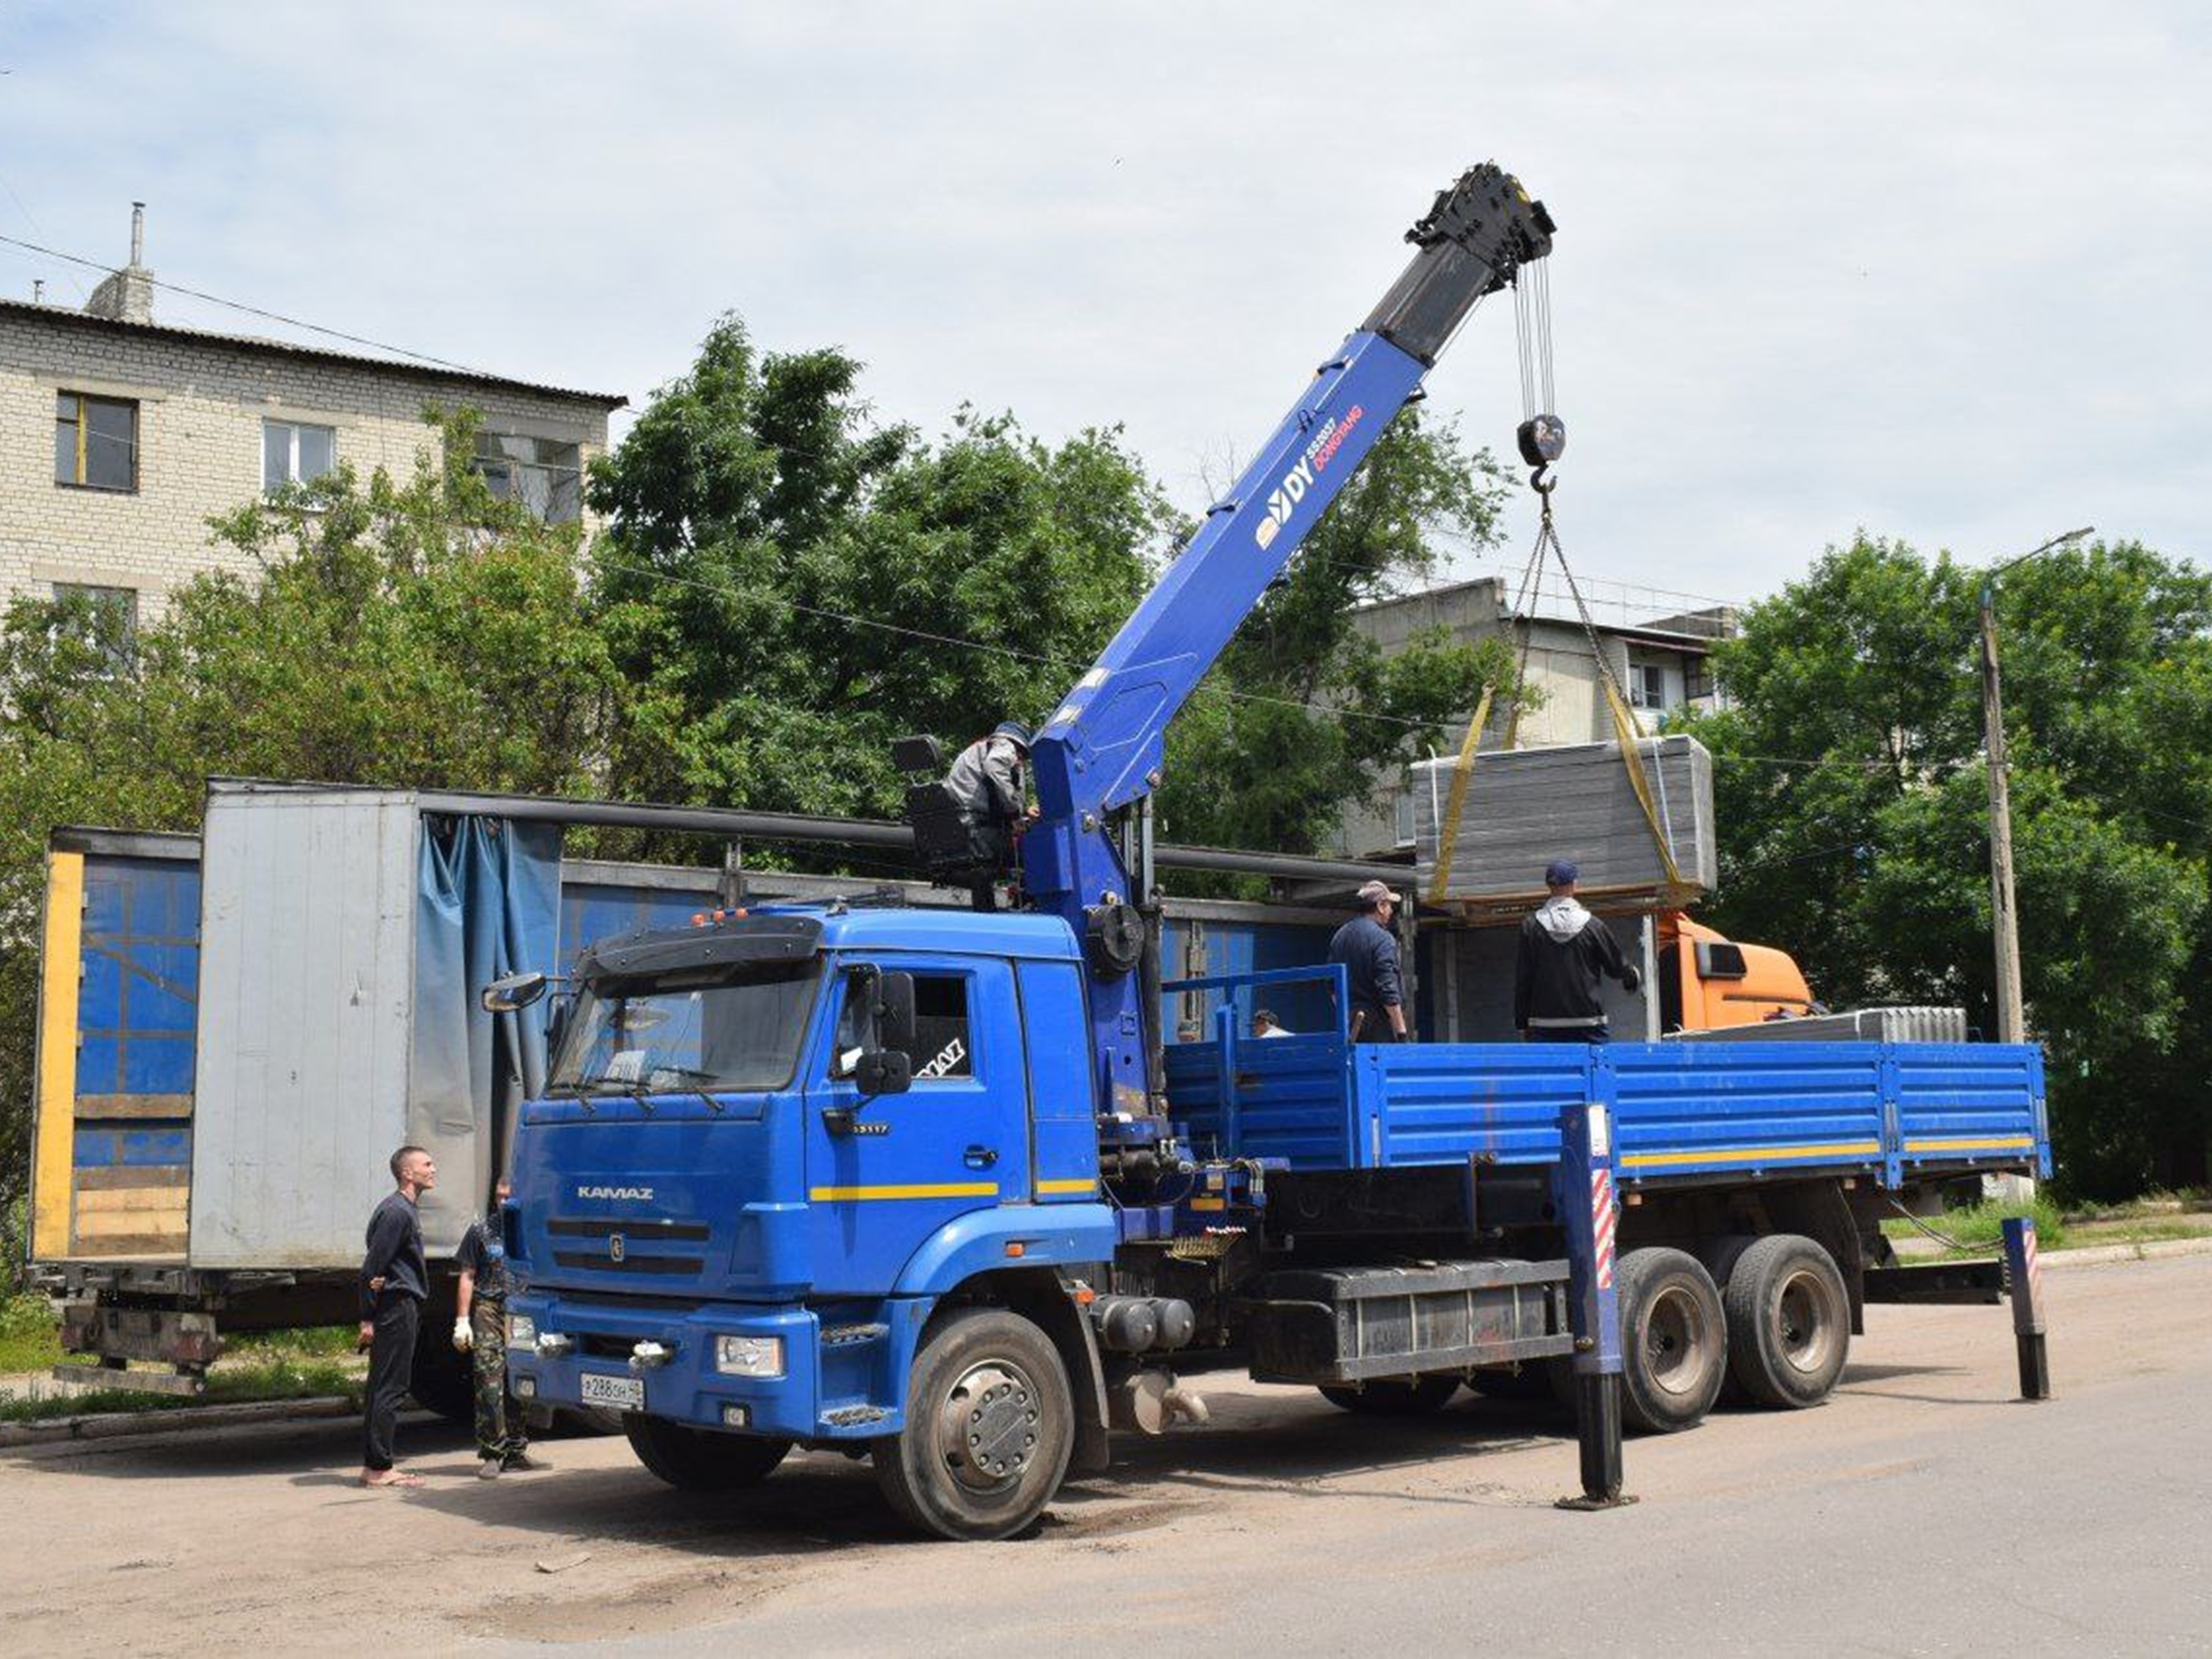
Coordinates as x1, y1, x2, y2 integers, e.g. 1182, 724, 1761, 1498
506, 1292, 927, 1440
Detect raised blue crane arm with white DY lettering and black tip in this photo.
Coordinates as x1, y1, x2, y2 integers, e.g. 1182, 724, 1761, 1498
1022, 164, 1553, 1113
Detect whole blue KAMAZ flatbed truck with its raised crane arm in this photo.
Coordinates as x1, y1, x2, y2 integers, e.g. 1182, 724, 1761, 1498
484, 166, 2048, 1538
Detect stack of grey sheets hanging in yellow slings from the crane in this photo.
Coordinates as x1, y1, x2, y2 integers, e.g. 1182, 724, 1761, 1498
1411, 737, 1717, 909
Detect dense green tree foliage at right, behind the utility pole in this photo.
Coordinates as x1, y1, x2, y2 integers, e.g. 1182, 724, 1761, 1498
1692, 538, 2212, 1195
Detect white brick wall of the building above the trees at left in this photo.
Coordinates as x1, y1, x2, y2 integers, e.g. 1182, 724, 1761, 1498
0, 307, 606, 617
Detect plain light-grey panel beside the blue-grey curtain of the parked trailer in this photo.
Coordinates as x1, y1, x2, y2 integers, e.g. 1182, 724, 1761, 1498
190, 790, 418, 1268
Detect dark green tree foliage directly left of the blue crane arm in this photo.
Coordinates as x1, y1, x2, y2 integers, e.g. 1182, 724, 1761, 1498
590, 316, 1168, 832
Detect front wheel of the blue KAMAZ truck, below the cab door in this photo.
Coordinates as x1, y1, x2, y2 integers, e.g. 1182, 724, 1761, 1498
873, 1307, 1075, 1540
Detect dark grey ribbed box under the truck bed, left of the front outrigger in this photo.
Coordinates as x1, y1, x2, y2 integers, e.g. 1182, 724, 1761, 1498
1248, 1261, 1575, 1385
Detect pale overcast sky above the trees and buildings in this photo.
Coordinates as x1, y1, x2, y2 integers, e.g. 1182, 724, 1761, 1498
0, 0, 2212, 600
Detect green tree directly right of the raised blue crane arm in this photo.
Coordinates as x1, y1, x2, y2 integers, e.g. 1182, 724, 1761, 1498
1159, 405, 1513, 851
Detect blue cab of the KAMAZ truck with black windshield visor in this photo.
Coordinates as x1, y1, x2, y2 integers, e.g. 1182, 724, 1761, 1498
504, 905, 1115, 1531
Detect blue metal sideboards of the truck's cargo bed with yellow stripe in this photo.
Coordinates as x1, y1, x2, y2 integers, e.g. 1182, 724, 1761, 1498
1164, 969, 2050, 1188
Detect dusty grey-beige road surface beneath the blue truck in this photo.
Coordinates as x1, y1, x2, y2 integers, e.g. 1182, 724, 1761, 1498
0, 1257, 2212, 1659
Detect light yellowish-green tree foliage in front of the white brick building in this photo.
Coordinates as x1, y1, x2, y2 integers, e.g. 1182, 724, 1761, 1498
0, 411, 626, 1247
